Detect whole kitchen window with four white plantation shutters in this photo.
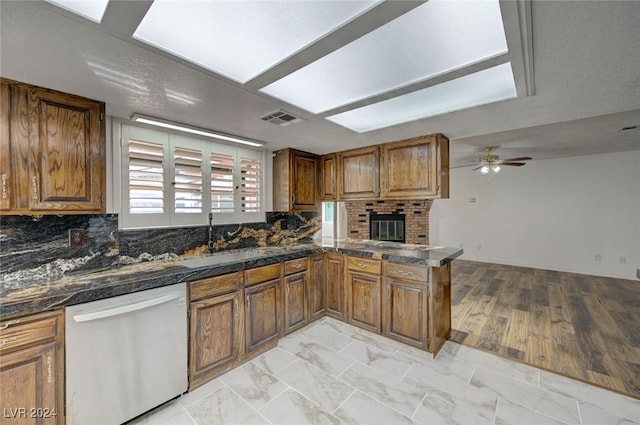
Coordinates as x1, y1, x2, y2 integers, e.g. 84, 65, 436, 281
121, 124, 265, 228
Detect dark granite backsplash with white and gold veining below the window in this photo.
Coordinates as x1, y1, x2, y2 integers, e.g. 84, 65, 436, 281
0, 212, 321, 282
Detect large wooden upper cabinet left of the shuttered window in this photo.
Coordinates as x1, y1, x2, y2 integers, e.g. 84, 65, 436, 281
0, 80, 106, 214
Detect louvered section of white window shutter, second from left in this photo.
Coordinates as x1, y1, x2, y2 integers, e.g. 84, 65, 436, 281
173, 147, 202, 214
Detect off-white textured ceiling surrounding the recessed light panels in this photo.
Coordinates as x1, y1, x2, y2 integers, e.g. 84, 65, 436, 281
0, 1, 640, 165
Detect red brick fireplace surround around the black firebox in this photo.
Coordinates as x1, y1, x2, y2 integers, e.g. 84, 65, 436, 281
345, 200, 433, 245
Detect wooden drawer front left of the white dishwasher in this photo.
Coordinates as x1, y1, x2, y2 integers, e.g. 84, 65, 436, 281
0, 312, 62, 354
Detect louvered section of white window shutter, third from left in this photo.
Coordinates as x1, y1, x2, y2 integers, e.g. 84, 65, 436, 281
210, 152, 236, 214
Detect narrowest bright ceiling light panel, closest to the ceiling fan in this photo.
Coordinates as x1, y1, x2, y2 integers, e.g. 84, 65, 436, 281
327, 63, 516, 133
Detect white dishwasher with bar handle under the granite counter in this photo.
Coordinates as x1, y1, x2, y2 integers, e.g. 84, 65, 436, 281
65, 283, 188, 425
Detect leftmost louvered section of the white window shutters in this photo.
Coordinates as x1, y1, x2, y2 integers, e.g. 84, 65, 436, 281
128, 140, 164, 214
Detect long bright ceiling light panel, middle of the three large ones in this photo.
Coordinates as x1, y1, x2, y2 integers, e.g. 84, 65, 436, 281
261, 0, 507, 113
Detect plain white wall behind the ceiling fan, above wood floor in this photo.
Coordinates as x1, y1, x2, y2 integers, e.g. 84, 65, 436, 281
429, 150, 640, 279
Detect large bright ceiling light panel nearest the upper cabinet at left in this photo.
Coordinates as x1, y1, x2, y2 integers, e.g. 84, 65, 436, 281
133, 0, 380, 83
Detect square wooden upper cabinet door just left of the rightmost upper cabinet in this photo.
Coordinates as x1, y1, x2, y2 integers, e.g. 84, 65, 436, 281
338, 146, 380, 199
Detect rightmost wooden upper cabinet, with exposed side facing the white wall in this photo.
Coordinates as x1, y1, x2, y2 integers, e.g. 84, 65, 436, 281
380, 134, 449, 199
